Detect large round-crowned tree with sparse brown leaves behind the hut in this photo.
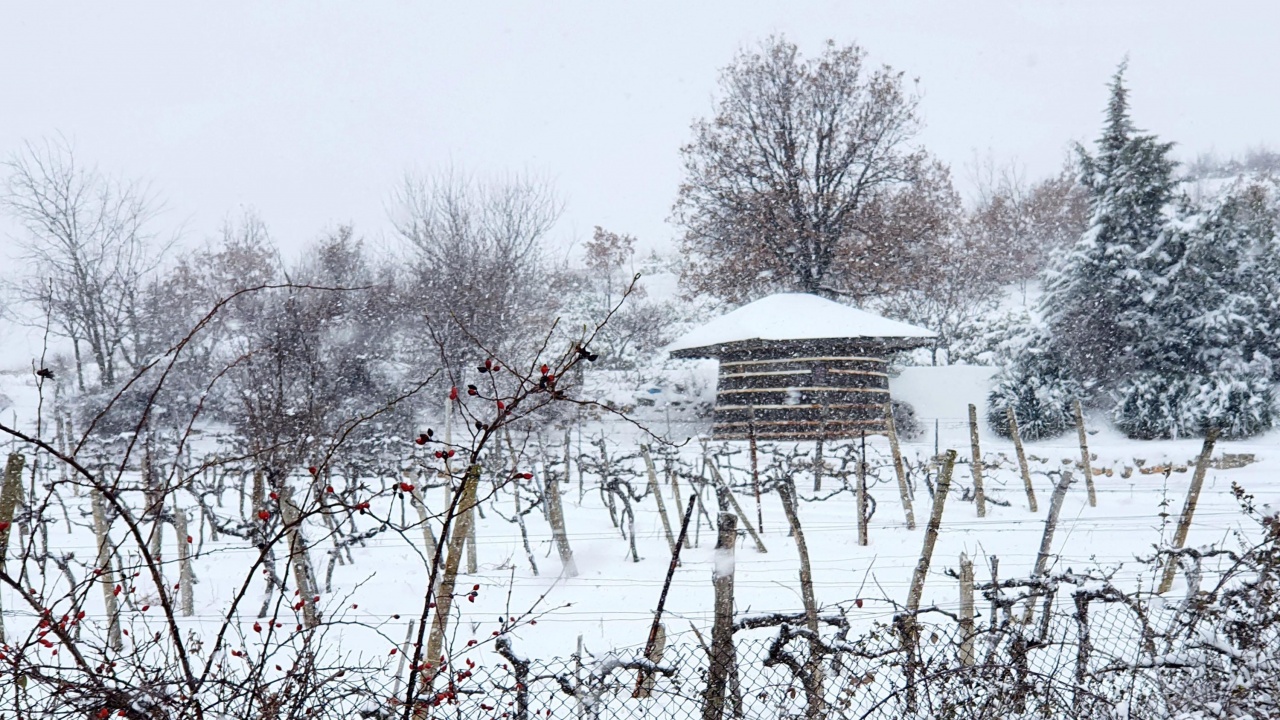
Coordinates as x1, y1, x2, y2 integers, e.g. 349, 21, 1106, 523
673, 37, 955, 301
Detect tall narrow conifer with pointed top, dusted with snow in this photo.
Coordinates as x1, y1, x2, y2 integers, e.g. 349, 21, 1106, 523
1041, 65, 1175, 393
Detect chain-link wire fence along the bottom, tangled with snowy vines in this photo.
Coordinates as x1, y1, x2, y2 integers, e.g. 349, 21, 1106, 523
389, 561, 1277, 720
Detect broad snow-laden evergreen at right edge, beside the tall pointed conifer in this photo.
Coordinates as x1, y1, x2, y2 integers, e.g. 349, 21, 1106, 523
1112, 183, 1277, 438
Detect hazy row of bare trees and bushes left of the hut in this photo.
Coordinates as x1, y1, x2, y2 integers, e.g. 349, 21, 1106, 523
3, 150, 680, 473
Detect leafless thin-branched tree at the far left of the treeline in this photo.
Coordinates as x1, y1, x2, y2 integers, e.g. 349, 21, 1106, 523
0, 141, 163, 389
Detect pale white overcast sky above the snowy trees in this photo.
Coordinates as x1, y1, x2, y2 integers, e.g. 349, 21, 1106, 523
0, 0, 1280, 265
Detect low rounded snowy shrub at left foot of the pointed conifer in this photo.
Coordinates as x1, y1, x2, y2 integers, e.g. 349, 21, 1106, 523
987, 347, 1084, 441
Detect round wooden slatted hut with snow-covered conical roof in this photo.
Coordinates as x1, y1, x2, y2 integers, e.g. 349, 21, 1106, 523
667, 293, 937, 439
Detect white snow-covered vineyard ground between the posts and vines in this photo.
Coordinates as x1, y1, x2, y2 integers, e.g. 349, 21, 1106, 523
0, 358, 1280, 664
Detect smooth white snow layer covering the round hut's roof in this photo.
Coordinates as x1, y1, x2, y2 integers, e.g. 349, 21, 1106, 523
667, 292, 937, 352
